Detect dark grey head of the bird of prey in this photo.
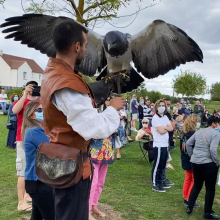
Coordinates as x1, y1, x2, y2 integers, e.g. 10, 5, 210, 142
103, 31, 129, 57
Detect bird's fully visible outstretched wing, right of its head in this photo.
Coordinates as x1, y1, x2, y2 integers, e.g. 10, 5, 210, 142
131, 20, 203, 79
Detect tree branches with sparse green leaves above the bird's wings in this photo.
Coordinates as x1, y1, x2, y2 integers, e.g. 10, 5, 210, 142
17, 0, 155, 27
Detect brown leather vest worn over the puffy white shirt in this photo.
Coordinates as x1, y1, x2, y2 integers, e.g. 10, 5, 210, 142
40, 58, 95, 179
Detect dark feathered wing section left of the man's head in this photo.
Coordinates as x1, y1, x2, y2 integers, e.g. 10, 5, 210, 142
0, 14, 70, 57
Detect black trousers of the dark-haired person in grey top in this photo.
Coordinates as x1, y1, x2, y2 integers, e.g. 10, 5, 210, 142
189, 162, 218, 213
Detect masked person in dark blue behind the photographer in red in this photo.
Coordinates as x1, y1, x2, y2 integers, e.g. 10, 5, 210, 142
6, 93, 19, 149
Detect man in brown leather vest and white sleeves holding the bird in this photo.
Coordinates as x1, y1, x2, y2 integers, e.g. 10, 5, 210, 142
41, 20, 124, 220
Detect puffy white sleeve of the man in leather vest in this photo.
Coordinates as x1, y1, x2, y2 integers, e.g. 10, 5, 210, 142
52, 88, 120, 140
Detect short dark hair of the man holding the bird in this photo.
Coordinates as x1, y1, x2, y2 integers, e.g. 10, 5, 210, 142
53, 20, 88, 54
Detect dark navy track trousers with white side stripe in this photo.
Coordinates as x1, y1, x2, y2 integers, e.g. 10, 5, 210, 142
152, 147, 168, 186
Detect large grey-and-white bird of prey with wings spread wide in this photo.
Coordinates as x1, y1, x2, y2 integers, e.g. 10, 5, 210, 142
0, 14, 203, 105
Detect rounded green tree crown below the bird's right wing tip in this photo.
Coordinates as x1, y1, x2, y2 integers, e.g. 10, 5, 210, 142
173, 70, 206, 97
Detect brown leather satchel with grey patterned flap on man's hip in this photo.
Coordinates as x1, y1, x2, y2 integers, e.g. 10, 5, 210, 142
35, 142, 84, 189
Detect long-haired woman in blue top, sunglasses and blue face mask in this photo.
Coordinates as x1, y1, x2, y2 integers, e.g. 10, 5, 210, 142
21, 101, 55, 220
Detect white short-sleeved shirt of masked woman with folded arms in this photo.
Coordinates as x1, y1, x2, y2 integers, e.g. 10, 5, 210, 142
151, 114, 170, 147
